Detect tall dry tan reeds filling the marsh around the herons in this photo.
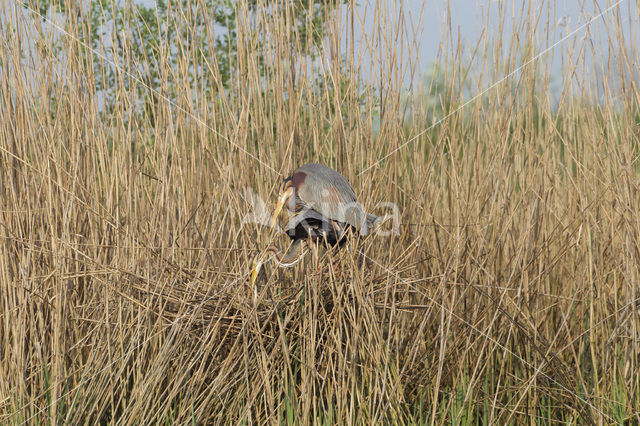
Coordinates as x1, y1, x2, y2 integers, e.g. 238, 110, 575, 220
0, 0, 640, 424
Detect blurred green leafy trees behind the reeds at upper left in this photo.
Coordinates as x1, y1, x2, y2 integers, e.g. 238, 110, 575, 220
23, 0, 346, 118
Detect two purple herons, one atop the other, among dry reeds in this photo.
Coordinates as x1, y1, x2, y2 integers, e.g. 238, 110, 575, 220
251, 163, 380, 288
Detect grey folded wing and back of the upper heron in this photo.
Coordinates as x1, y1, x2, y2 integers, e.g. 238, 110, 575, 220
296, 163, 369, 235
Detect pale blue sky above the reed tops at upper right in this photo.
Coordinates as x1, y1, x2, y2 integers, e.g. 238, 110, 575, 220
12, 0, 640, 92
